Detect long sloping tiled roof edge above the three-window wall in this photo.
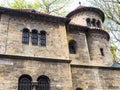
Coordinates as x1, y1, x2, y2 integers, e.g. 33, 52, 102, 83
0, 7, 69, 22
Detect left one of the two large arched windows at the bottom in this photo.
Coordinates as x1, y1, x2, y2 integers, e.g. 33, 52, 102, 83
18, 75, 32, 90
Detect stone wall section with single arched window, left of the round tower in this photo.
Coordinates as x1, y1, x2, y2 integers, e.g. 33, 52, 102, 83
67, 29, 90, 65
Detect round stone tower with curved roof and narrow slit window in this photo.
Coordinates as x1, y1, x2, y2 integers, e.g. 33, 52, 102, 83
67, 6, 113, 66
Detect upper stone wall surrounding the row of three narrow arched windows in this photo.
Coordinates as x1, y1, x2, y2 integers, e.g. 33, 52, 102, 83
0, 14, 69, 59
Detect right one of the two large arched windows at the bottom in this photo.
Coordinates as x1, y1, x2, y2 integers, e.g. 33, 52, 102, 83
36, 75, 50, 90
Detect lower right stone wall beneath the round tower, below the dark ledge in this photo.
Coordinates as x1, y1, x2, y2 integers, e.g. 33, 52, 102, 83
72, 66, 120, 90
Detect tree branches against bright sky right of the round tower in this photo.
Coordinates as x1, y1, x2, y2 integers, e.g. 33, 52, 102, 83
88, 0, 120, 61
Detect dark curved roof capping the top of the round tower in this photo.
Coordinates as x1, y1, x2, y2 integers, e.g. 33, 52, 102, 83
66, 5, 105, 22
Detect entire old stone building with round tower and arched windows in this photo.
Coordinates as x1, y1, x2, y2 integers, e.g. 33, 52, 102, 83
0, 6, 120, 90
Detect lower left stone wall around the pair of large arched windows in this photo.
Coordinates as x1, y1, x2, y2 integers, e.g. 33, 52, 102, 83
0, 56, 72, 90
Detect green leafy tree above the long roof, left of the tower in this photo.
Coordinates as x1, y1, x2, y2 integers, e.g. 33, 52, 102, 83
1, 0, 71, 16
